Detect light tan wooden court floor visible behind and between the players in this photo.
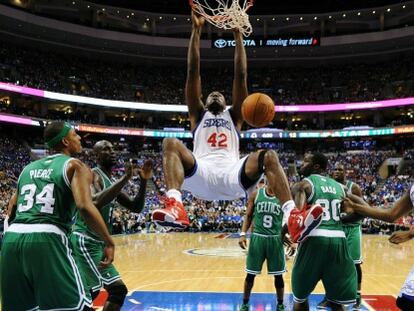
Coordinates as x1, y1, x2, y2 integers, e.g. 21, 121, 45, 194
111, 233, 414, 296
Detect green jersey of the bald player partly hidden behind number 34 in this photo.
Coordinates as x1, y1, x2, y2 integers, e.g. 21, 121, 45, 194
73, 167, 114, 239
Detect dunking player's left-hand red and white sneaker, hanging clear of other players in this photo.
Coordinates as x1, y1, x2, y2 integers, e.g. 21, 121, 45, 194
152, 198, 190, 229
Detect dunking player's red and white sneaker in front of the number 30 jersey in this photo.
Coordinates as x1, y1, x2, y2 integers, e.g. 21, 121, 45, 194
288, 204, 323, 243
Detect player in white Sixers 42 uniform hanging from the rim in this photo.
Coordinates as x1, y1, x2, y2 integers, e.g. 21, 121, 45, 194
152, 12, 322, 241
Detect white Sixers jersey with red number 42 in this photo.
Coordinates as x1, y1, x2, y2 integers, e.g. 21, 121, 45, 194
193, 110, 240, 165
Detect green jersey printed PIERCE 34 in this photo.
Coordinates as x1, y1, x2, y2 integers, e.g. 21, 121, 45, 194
14, 154, 76, 232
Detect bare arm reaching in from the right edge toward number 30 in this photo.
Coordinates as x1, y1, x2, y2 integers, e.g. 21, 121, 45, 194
342, 191, 413, 222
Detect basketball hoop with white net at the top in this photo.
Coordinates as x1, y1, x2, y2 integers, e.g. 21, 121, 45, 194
189, 0, 254, 37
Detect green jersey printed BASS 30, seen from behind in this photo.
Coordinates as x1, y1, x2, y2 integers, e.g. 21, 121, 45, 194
305, 174, 345, 230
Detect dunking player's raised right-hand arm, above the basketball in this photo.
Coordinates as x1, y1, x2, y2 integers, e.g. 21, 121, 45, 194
232, 29, 248, 130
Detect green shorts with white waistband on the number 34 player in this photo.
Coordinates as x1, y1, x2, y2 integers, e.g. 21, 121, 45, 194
0, 224, 92, 311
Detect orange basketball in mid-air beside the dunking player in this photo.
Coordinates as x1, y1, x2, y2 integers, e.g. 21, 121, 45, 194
242, 93, 275, 127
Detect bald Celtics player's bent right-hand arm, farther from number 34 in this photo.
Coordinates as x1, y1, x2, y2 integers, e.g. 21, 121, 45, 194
117, 160, 153, 213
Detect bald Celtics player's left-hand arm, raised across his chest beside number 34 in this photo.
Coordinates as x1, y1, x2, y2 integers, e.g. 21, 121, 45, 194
92, 163, 133, 209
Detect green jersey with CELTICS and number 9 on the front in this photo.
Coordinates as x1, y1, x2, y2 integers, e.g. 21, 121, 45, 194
253, 187, 283, 235
